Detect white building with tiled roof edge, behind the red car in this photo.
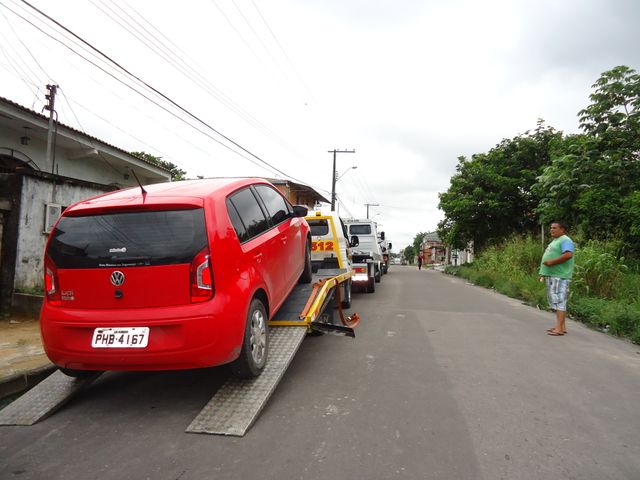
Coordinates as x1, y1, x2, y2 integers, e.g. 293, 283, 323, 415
0, 97, 171, 311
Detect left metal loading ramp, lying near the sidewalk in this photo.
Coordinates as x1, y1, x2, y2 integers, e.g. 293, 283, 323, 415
0, 370, 100, 426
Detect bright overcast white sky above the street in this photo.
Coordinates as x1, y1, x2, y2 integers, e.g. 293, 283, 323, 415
0, 0, 640, 251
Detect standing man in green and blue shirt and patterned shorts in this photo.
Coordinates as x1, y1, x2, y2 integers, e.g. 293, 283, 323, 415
539, 222, 575, 337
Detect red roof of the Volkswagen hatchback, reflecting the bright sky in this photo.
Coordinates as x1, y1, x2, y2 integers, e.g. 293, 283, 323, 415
65, 177, 270, 213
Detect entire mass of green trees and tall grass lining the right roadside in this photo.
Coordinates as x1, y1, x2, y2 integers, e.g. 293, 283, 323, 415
420, 66, 640, 343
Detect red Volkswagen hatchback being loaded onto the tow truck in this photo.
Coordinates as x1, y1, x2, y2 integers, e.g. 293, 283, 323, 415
40, 179, 311, 377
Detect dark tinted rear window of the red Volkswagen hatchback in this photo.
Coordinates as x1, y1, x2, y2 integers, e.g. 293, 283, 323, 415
47, 208, 207, 268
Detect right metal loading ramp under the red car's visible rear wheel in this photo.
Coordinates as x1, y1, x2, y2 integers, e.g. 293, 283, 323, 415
186, 325, 307, 437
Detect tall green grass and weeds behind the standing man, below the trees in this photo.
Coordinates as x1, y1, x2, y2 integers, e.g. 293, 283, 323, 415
445, 237, 640, 344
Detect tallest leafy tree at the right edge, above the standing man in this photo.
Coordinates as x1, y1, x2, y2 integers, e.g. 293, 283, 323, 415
534, 66, 640, 255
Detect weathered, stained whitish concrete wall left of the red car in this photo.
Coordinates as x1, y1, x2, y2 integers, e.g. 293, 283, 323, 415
14, 176, 110, 291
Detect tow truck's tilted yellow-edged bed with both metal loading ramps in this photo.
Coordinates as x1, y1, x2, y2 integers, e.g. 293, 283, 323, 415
0, 265, 359, 437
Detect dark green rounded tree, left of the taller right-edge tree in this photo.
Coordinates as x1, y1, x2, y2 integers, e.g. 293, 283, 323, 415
438, 120, 562, 250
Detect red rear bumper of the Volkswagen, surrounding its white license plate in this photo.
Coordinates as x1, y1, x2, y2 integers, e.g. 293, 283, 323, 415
40, 302, 245, 370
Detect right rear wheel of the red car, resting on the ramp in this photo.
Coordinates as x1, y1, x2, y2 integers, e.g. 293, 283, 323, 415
231, 298, 269, 378
